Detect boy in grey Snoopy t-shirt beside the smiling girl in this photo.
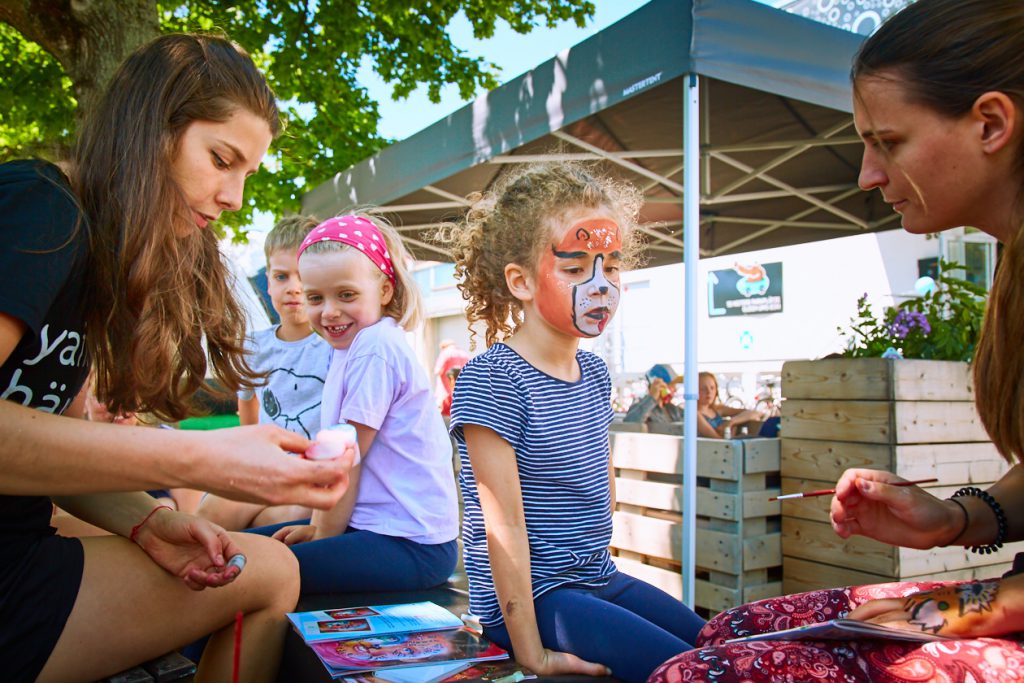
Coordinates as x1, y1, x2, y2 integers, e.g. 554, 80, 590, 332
199, 216, 331, 530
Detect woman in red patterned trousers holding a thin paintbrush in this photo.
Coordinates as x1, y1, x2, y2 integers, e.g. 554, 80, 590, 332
651, 0, 1024, 683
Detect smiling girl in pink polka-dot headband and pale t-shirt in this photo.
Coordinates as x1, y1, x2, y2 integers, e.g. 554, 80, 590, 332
261, 215, 459, 593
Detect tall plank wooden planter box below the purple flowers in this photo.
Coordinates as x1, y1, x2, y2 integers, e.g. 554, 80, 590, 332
780, 358, 1014, 593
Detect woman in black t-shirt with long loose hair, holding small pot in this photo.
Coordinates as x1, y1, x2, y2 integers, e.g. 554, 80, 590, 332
0, 35, 350, 681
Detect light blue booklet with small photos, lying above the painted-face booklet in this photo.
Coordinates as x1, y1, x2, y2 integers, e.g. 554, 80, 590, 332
288, 602, 462, 644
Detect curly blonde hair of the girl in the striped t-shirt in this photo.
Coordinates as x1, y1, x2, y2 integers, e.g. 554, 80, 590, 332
437, 162, 642, 348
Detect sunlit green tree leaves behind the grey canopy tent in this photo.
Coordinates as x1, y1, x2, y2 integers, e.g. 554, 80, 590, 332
0, 0, 594, 239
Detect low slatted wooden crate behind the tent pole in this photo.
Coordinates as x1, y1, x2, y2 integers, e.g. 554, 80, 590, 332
611, 432, 782, 613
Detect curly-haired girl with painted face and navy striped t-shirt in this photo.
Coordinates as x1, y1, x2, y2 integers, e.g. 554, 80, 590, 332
442, 164, 703, 683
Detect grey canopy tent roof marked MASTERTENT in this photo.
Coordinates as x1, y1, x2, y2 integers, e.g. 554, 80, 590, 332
303, 0, 897, 265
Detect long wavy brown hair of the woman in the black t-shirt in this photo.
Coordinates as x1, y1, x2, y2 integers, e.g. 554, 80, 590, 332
72, 35, 281, 420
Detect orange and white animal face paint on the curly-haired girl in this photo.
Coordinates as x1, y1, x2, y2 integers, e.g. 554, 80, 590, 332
537, 217, 623, 338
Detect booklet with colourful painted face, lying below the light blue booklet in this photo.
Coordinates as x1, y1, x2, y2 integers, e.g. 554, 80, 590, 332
310, 628, 508, 678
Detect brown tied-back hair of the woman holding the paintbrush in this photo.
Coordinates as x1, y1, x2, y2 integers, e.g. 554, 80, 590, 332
852, 0, 1024, 462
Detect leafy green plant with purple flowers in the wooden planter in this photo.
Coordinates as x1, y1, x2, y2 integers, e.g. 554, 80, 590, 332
839, 261, 986, 361
